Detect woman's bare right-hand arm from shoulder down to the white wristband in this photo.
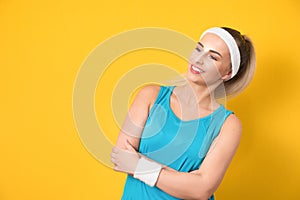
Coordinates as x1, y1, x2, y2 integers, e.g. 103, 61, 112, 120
156, 114, 242, 200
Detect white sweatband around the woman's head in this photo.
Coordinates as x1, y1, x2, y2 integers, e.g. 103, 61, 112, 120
200, 27, 241, 78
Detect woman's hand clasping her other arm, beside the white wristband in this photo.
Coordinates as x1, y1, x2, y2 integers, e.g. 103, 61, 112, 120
111, 140, 141, 175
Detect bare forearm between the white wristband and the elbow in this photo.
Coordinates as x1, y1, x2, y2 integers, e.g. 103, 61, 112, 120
156, 168, 211, 200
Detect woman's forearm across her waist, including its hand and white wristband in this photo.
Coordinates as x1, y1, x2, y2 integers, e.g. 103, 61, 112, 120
111, 147, 212, 200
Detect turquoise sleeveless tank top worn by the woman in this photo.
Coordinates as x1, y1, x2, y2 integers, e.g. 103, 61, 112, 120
122, 85, 233, 200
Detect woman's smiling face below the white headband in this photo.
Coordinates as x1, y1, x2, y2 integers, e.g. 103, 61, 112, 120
187, 33, 231, 86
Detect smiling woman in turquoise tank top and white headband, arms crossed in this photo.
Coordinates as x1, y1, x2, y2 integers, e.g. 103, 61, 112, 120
111, 27, 255, 200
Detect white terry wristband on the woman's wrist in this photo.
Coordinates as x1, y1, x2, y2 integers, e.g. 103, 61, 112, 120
133, 157, 162, 187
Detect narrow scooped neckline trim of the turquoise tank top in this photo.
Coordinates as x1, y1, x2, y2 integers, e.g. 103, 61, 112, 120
167, 85, 224, 123
